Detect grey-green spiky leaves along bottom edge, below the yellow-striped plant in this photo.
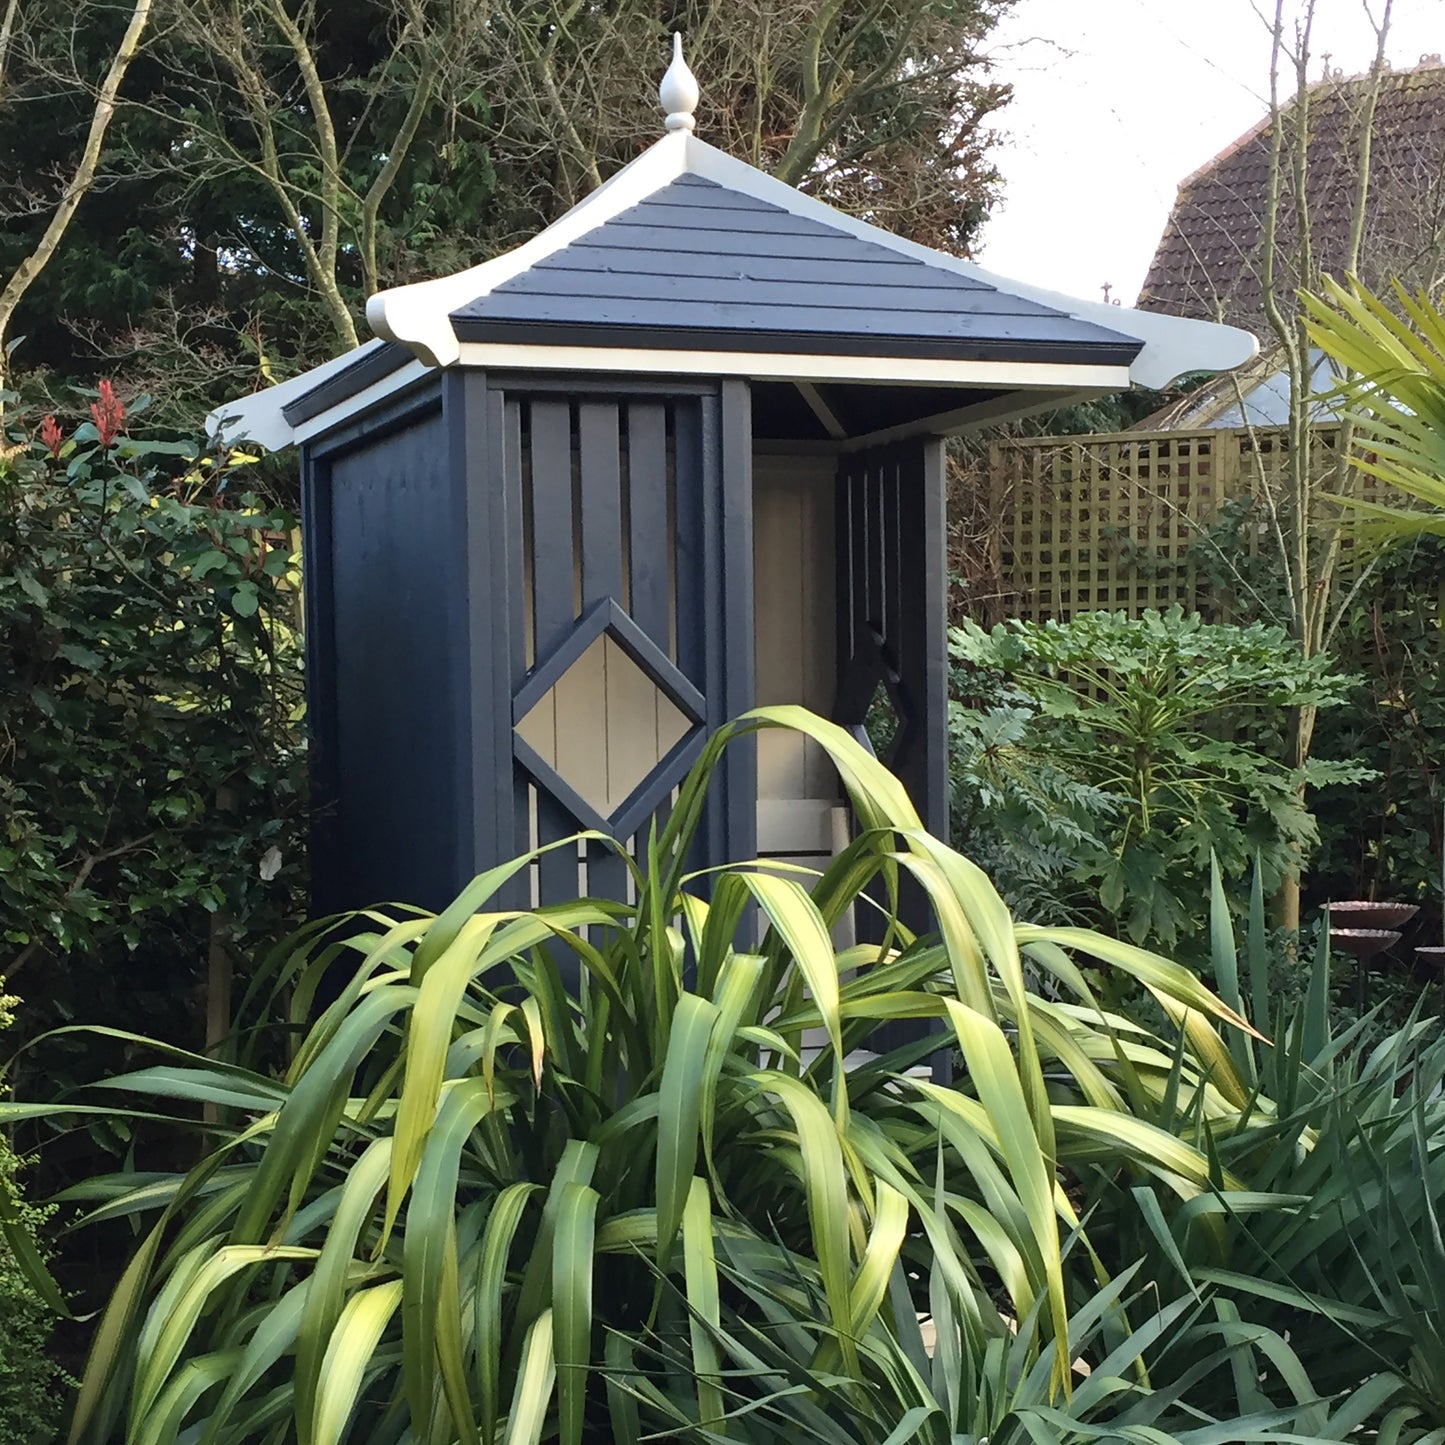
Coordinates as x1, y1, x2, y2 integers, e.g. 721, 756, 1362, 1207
608, 1231, 1406, 1445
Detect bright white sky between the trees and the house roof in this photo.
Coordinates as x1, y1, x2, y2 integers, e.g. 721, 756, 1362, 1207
975, 0, 1445, 305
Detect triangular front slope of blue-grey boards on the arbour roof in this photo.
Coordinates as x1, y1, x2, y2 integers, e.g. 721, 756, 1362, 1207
452, 175, 1142, 363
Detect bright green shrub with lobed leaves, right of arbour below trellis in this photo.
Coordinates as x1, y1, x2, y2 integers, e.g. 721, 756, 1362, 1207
952, 607, 1368, 946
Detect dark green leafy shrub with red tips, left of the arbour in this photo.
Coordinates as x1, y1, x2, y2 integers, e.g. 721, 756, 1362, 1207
0, 389, 303, 1080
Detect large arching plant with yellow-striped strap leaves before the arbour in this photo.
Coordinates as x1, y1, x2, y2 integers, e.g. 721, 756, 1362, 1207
0, 708, 1317, 1445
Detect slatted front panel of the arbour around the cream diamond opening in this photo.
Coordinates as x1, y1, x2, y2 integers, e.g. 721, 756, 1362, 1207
493, 383, 756, 902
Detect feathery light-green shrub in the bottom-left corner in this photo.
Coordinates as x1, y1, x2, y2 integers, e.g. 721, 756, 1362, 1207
0, 978, 64, 1445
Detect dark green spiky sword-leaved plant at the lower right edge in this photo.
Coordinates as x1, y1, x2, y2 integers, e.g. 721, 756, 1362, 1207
1211, 887, 1445, 1441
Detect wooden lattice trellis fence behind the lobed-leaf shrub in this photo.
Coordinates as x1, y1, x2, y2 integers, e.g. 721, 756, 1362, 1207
988, 428, 1338, 620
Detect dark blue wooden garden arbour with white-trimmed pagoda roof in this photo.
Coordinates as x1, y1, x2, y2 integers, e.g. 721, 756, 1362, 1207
218, 39, 1253, 912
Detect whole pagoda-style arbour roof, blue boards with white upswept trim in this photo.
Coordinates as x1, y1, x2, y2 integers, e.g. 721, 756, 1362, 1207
210, 41, 1256, 447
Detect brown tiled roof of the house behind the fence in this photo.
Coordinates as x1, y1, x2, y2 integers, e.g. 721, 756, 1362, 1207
1139, 55, 1445, 328
